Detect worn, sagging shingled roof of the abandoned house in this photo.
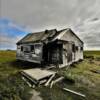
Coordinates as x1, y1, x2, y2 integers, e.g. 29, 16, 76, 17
17, 28, 83, 44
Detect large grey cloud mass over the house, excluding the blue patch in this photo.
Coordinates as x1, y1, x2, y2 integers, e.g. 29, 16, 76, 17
0, 0, 100, 47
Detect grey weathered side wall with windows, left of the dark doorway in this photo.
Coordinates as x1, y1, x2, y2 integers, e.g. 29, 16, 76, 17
17, 43, 42, 63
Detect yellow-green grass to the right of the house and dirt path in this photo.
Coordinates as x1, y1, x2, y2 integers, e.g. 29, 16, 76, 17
38, 51, 100, 100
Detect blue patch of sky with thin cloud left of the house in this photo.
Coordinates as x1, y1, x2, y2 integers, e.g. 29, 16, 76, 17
0, 18, 28, 49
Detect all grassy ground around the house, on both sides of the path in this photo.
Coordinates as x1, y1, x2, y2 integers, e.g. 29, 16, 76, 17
0, 51, 100, 100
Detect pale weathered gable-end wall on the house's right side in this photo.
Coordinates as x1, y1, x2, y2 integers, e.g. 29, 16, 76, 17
56, 30, 83, 67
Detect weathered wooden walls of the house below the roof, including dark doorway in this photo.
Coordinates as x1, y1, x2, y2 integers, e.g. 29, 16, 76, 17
17, 29, 83, 67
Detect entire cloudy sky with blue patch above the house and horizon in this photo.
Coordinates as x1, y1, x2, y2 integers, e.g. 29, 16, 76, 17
0, 0, 100, 50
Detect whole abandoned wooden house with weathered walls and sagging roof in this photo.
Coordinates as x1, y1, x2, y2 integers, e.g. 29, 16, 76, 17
16, 28, 83, 67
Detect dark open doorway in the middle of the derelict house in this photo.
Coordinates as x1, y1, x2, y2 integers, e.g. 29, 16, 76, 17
43, 43, 63, 64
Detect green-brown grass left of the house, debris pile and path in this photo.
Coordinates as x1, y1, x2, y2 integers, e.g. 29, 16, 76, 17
0, 51, 32, 100
